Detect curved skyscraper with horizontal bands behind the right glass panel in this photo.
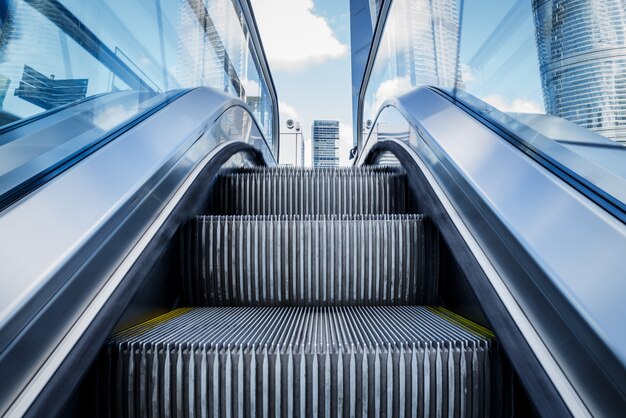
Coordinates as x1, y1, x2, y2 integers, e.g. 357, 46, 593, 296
532, 0, 626, 143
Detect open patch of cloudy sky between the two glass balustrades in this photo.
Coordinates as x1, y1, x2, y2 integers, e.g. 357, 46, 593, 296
252, 0, 352, 165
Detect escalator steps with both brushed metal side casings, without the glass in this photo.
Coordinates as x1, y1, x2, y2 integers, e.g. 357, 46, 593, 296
0, 85, 623, 417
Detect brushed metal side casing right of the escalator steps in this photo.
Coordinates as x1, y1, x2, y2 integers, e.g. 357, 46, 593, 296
360, 89, 626, 416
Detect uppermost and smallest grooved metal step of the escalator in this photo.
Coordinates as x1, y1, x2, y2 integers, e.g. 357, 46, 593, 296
216, 167, 406, 215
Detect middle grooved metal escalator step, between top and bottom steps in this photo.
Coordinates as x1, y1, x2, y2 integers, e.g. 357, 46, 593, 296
181, 215, 438, 306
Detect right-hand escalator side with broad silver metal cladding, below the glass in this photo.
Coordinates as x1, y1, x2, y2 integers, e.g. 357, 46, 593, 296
357, 88, 626, 413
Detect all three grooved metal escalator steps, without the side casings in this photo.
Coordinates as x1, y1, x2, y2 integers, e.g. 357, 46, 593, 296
94, 167, 512, 417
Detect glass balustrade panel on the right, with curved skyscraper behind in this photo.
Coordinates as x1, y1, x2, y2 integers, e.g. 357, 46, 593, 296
362, 0, 626, 207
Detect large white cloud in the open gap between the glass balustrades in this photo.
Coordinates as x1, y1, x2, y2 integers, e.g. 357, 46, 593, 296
252, 0, 348, 71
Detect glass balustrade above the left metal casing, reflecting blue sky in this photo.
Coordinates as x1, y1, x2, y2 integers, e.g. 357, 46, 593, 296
0, 0, 277, 207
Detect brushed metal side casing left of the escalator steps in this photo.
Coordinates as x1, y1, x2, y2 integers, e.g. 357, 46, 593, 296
0, 88, 275, 414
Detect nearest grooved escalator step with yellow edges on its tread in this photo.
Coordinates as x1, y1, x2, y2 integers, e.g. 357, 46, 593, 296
101, 306, 503, 417
